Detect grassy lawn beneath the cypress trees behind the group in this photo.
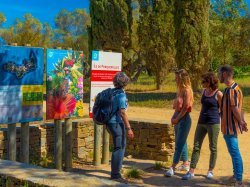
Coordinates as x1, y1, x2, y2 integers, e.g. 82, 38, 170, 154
126, 74, 250, 112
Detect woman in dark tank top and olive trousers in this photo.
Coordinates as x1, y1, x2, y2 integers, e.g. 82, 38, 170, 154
182, 72, 223, 180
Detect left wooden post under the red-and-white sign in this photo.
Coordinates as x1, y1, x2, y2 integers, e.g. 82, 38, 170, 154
94, 123, 103, 166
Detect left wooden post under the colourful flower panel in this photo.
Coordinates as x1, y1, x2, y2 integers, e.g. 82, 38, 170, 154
54, 119, 62, 170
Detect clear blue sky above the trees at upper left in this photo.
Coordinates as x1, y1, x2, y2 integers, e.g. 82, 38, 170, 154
0, 0, 89, 27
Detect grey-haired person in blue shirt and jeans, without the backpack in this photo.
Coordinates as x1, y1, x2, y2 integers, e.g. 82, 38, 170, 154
106, 72, 134, 183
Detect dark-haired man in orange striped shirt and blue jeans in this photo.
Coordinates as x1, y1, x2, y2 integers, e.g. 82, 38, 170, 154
219, 65, 247, 186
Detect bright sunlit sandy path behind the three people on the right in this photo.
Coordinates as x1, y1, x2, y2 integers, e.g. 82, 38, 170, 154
128, 107, 250, 186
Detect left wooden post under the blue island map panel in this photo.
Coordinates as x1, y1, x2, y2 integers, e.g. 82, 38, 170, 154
8, 123, 16, 161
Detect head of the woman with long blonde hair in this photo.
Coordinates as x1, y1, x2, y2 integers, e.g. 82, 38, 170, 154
175, 69, 191, 91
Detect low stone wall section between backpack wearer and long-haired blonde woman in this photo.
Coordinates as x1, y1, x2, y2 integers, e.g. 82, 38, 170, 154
126, 120, 174, 161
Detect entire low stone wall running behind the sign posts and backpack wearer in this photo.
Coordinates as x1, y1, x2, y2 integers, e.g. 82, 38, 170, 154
0, 119, 174, 162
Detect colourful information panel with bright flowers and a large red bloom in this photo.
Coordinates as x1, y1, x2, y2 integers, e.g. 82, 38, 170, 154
46, 49, 83, 119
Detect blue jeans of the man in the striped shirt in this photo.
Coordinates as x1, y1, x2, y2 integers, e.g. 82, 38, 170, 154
224, 135, 243, 181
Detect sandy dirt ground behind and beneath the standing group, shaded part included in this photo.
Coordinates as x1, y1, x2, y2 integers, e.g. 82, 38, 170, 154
81, 106, 250, 186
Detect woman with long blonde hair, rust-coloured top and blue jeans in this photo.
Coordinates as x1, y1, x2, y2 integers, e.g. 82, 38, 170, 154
165, 69, 194, 177
